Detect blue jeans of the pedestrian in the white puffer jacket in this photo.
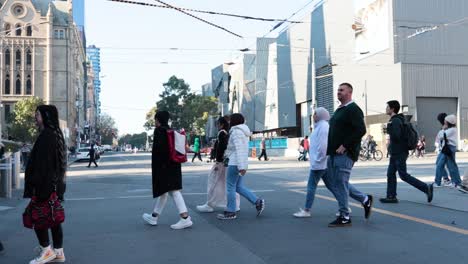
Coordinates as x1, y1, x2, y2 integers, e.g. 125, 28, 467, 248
226, 166, 258, 213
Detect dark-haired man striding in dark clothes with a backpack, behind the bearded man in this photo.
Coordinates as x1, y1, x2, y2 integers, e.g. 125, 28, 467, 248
380, 100, 434, 203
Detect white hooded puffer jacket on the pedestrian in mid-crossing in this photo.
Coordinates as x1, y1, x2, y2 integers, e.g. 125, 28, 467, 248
226, 124, 252, 170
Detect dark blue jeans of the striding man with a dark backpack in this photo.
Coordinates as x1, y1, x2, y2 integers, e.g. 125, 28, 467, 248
387, 155, 428, 198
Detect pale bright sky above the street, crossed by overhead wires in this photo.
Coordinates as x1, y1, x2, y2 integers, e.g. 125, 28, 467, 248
86, 0, 317, 135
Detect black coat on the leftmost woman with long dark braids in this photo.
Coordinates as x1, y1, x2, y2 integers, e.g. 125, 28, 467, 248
23, 128, 65, 201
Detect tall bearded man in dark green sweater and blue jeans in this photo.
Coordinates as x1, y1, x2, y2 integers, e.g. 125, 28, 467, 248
327, 83, 373, 227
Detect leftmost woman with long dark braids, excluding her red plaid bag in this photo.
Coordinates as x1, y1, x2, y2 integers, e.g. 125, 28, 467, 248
24, 105, 67, 264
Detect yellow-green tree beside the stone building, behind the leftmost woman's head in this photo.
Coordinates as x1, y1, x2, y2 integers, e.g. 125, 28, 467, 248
8, 97, 44, 143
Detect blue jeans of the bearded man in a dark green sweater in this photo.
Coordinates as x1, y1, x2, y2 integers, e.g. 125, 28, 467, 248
327, 155, 367, 216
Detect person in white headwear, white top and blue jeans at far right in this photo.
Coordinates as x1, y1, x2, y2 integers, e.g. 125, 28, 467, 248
435, 115, 461, 188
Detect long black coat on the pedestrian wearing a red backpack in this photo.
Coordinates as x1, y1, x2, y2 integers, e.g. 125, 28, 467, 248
151, 126, 182, 198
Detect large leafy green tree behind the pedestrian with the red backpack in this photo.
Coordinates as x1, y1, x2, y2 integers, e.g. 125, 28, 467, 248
154, 76, 218, 134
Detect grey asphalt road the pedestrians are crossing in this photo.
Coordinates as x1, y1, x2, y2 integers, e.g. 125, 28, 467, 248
0, 154, 468, 264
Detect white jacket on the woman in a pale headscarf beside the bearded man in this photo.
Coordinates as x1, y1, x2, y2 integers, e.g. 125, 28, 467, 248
309, 120, 330, 170
